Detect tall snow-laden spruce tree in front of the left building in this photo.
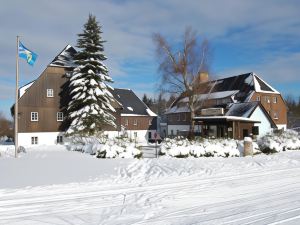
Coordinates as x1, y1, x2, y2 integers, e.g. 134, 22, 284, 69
67, 15, 116, 136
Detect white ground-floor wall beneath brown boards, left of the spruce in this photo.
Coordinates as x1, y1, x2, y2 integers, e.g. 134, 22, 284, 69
18, 132, 65, 146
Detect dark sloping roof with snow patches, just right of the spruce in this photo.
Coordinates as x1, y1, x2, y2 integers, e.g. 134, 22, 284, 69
112, 88, 157, 116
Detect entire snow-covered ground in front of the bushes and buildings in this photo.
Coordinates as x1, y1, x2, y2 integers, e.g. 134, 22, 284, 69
0, 147, 300, 225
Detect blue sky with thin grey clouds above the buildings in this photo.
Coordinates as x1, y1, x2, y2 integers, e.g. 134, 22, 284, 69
0, 0, 300, 116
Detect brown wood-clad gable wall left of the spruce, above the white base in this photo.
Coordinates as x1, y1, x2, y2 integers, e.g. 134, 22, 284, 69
18, 67, 67, 133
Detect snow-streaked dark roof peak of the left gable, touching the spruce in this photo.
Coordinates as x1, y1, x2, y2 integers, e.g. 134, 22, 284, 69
49, 45, 77, 67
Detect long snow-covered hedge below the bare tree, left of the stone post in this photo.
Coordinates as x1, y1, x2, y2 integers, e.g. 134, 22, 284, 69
161, 137, 240, 158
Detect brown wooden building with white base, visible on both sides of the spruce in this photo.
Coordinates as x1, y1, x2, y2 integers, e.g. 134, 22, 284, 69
18, 45, 157, 146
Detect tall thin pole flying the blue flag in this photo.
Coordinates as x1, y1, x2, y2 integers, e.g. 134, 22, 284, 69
15, 36, 19, 158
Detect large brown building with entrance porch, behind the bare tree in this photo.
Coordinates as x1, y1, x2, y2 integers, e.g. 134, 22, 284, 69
166, 73, 287, 139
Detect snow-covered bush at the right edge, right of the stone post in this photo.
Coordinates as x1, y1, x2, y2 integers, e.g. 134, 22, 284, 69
258, 130, 300, 153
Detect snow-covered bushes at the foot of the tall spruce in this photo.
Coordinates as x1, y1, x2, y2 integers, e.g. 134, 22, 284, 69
69, 136, 142, 158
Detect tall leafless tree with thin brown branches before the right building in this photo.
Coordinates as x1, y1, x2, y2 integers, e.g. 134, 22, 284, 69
153, 28, 212, 135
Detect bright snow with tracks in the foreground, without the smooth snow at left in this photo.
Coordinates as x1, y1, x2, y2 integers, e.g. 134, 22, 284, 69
0, 154, 300, 225
